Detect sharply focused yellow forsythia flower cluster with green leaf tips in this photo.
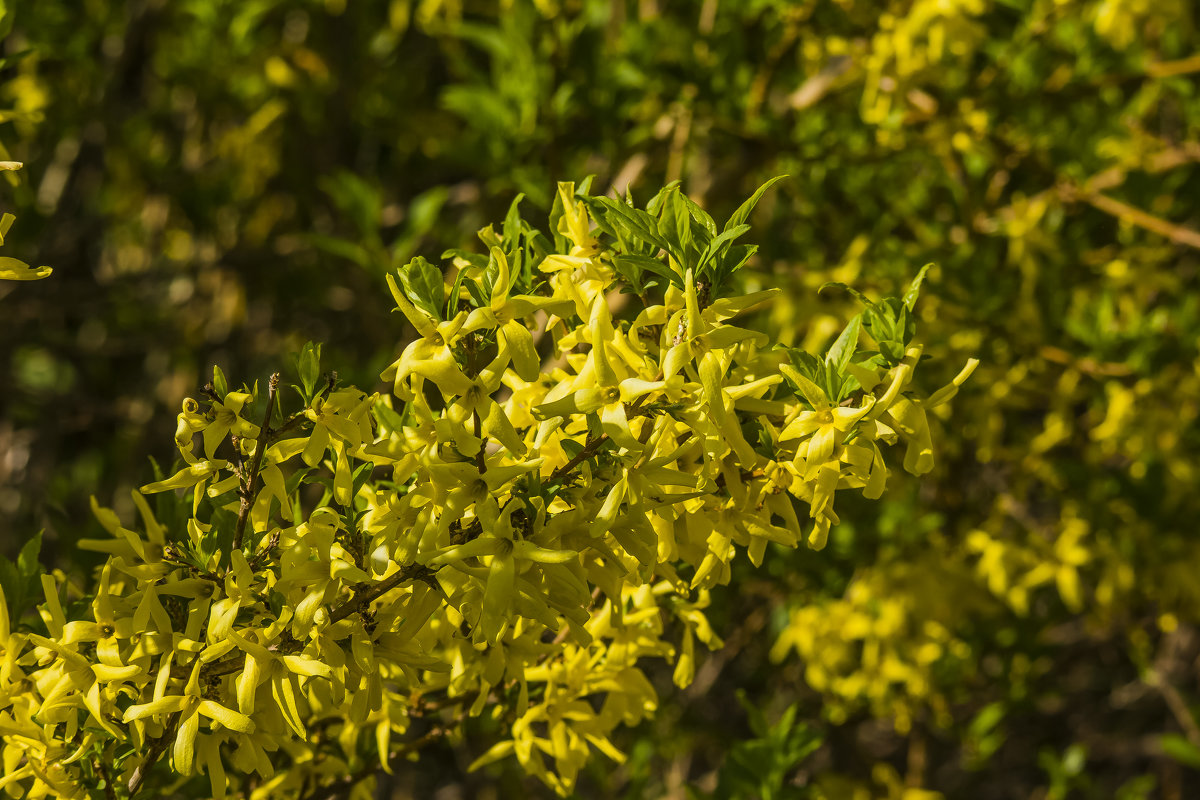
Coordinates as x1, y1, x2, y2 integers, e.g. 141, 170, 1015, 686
0, 184, 976, 798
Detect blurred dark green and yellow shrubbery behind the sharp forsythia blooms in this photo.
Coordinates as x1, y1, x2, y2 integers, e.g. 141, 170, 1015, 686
0, 0, 1200, 800
